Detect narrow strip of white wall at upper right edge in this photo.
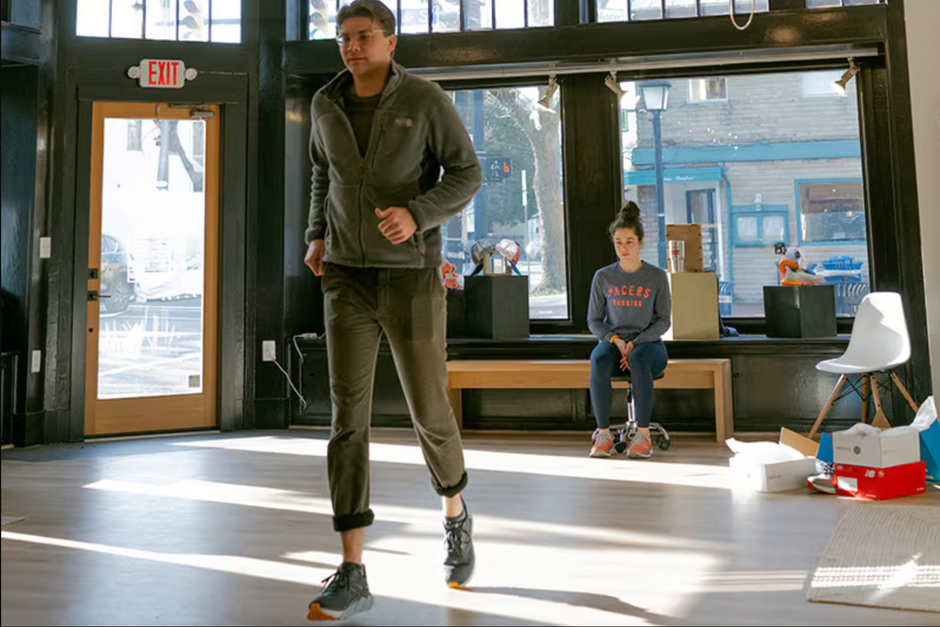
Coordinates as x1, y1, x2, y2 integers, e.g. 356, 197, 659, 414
904, 0, 940, 394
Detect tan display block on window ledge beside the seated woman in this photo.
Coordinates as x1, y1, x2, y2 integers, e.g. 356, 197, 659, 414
663, 272, 721, 340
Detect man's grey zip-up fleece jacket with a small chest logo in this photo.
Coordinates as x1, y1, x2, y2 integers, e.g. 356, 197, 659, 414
305, 62, 483, 268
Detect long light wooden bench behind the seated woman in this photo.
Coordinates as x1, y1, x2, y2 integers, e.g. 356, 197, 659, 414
447, 359, 734, 442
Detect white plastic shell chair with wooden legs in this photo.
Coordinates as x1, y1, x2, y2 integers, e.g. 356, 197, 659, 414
809, 292, 918, 437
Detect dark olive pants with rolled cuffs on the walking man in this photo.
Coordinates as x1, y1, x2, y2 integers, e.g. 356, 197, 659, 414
323, 264, 467, 531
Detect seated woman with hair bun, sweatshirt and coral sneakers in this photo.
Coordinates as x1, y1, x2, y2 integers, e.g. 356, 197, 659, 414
588, 202, 672, 458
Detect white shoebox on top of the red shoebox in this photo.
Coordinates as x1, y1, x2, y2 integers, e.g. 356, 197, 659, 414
832, 427, 920, 468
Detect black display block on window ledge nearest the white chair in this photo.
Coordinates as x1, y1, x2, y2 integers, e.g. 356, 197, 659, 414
764, 285, 837, 338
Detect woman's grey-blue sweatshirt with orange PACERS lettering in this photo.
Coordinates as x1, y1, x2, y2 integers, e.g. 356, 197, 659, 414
588, 261, 672, 346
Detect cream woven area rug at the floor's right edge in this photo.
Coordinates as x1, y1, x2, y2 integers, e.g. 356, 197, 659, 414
807, 503, 940, 613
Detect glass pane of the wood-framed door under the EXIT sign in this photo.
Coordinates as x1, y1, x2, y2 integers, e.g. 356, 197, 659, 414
98, 119, 206, 399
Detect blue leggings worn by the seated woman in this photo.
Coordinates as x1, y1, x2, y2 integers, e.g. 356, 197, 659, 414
591, 341, 669, 429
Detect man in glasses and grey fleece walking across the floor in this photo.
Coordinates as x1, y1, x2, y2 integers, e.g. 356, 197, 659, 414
305, 0, 482, 620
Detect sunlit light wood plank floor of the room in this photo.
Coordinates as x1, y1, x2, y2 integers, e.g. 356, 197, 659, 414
2, 430, 940, 625
